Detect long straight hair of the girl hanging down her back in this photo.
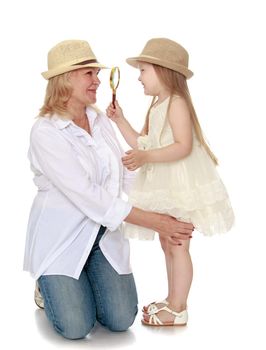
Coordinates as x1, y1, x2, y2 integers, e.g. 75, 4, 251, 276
142, 64, 218, 165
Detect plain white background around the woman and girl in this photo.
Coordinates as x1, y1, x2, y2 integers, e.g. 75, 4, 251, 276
0, 0, 266, 350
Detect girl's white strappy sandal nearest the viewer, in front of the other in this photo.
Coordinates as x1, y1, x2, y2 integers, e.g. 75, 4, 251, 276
141, 306, 188, 327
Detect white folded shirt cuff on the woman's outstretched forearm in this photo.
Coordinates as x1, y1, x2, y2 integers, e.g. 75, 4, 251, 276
101, 198, 132, 232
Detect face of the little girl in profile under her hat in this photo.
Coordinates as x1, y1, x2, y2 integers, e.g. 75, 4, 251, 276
139, 62, 162, 96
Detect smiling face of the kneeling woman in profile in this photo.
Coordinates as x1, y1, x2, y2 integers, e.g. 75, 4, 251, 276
70, 68, 101, 106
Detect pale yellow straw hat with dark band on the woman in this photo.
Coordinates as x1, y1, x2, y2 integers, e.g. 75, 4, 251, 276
42, 40, 107, 79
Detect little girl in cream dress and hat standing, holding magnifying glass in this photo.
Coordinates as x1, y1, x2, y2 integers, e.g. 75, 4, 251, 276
107, 38, 234, 326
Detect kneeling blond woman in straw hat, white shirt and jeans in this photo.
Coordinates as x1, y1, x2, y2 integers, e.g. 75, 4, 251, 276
24, 40, 193, 339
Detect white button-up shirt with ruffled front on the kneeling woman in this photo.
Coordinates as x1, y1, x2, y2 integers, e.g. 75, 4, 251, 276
24, 107, 134, 279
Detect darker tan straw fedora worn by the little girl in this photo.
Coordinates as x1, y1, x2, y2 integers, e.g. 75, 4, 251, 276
126, 38, 193, 79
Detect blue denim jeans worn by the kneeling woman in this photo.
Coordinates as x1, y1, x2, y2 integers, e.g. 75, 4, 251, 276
38, 226, 138, 339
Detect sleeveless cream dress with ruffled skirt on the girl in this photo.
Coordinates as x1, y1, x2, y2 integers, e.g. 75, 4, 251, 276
123, 98, 234, 240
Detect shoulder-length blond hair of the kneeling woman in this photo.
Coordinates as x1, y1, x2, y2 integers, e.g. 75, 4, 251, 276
39, 72, 72, 117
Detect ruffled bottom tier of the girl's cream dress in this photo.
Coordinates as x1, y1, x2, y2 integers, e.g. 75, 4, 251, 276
126, 183, 234, 235
